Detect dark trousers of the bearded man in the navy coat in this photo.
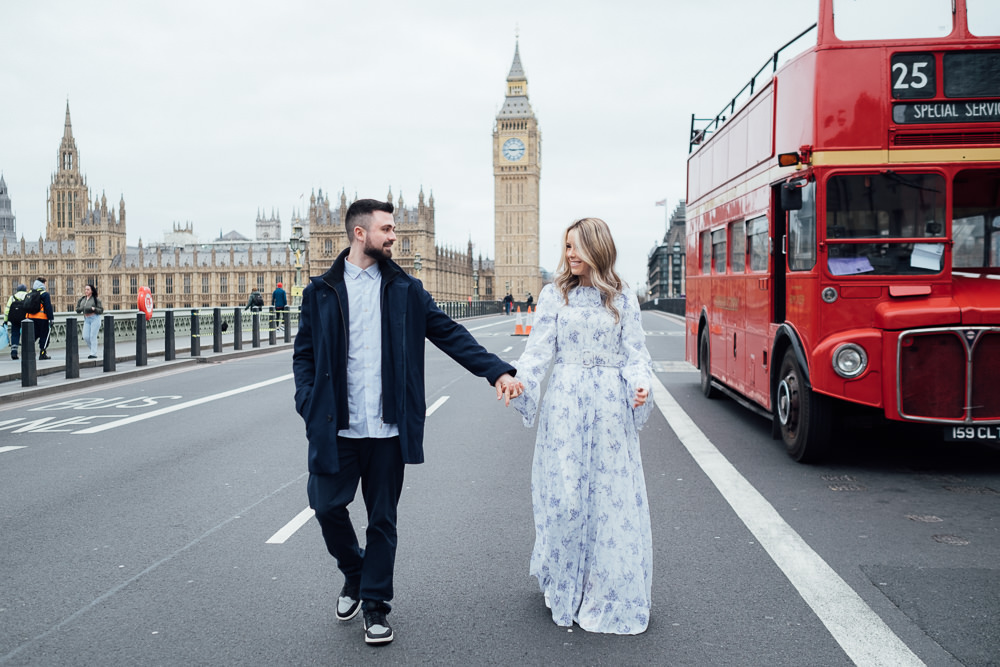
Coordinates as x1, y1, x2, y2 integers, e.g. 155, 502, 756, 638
308, 437, 405, 612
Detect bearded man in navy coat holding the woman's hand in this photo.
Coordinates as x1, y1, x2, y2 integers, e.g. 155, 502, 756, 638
292, 199, 523, 644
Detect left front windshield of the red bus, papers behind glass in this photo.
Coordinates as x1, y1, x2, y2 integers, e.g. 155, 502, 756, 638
826, 171, 946, 276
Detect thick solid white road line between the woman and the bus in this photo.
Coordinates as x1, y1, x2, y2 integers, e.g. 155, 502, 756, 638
653, 377, 924, 667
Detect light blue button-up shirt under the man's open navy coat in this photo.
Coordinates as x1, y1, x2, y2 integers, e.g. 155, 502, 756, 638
337, 261, 399, 438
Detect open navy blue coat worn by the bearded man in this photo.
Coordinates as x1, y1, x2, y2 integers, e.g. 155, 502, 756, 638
292, 250, 516, 474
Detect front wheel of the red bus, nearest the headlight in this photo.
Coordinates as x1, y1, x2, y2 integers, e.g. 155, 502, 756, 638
775, 349, 833, 463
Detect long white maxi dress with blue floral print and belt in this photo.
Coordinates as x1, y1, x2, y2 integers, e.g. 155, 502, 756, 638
514, 285, 653, 634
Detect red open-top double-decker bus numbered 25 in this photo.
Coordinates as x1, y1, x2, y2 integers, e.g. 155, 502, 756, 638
686, 0, 1000, 461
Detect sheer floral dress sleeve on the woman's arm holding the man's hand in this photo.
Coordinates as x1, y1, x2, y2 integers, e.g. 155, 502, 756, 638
511, 284, 563, 428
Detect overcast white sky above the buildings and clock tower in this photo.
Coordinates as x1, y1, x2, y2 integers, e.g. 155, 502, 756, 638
0, 0, 816, 285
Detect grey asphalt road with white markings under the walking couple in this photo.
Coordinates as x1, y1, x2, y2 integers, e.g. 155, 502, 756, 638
0, 313, 1000, 666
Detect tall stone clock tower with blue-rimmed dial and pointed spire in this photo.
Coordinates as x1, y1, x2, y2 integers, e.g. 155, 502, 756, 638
493, 44, 542, 301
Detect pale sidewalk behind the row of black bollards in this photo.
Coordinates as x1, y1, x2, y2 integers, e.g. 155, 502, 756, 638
0, 331, 295, 405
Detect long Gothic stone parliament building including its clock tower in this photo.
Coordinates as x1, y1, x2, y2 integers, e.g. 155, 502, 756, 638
0, 47, 541, 312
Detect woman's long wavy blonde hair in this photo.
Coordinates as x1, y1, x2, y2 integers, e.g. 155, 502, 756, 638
555, 218, 624, 323
